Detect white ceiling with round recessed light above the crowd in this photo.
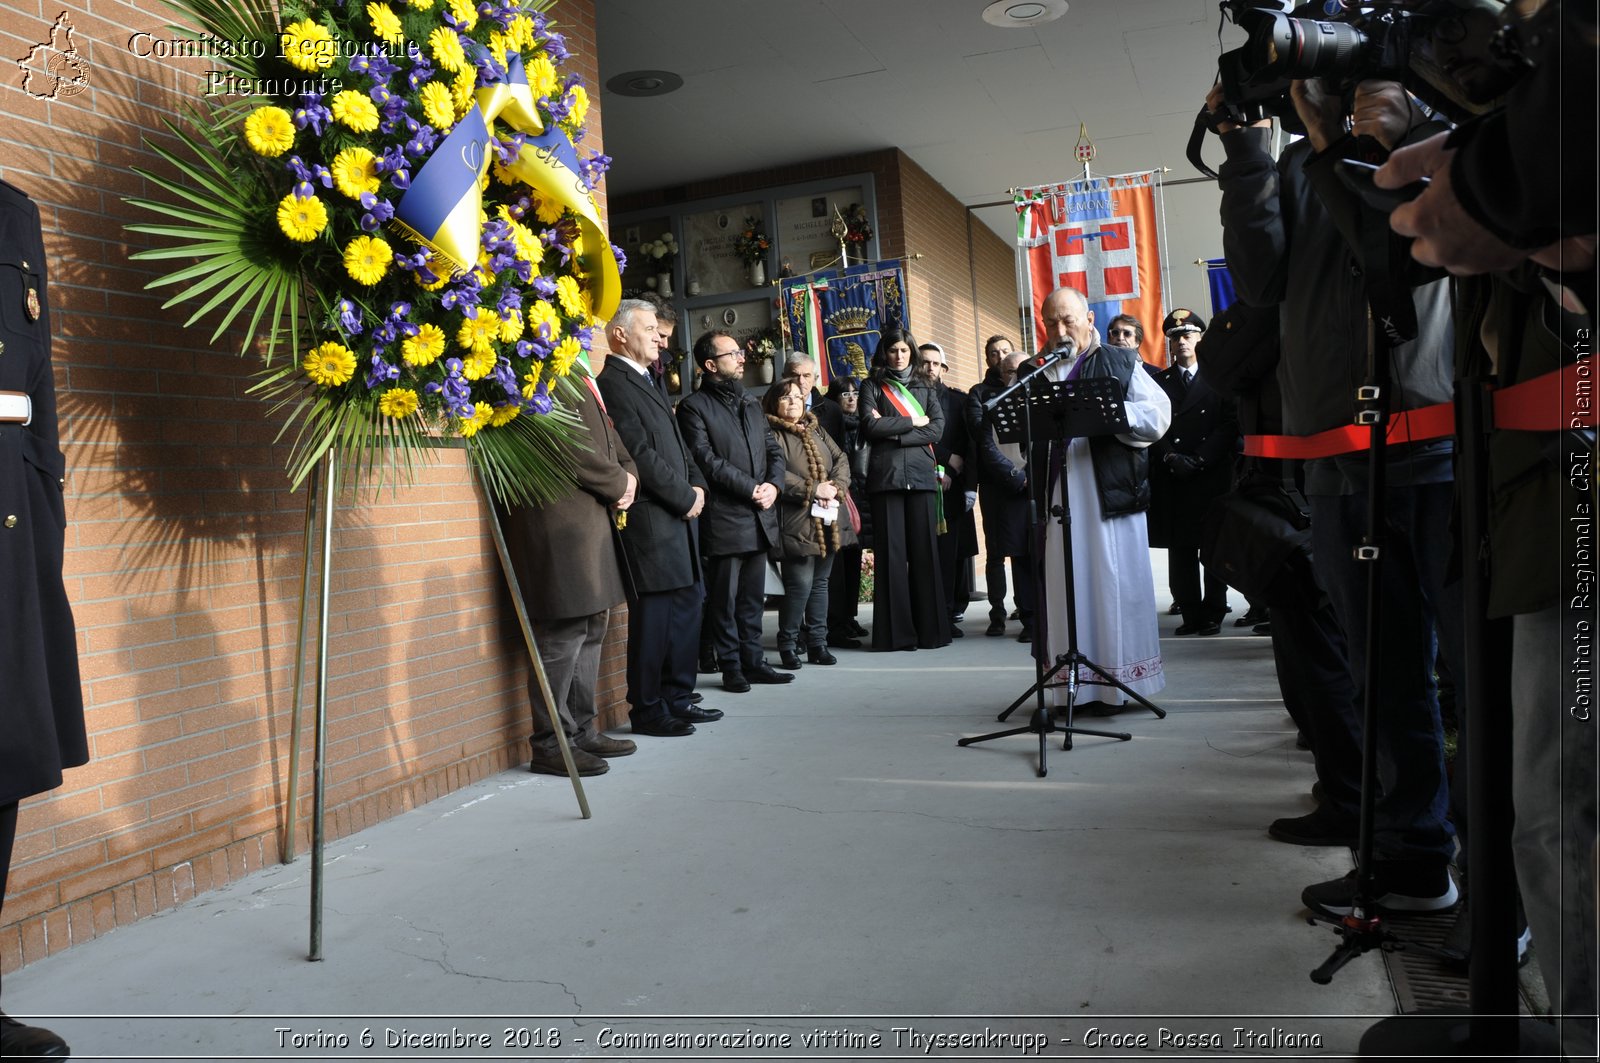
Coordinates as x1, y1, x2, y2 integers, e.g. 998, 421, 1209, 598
595, 0, 1240, 235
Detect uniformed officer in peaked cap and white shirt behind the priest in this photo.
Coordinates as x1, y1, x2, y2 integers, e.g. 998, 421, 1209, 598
1150, 307, 1240, 636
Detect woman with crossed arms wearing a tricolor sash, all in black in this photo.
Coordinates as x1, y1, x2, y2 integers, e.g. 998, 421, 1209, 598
861, 328, 950, 650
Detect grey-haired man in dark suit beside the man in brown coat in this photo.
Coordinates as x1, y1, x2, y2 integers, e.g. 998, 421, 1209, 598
598, 299, 722, 736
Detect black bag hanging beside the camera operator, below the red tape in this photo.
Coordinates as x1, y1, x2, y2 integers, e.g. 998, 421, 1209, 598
1200, 477, 1322, 607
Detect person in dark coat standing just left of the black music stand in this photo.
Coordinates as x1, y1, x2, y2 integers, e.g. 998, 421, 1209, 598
965, 355, 1037, 642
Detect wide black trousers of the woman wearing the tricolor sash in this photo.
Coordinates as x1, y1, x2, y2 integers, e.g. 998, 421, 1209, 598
872, 491, 950, 650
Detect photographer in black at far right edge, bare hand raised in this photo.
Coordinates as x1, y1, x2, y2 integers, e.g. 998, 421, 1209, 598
1379, 5, 1600, 1058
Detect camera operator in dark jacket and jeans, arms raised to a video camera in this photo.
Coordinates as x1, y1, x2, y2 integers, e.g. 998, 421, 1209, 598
1206, 80, 1461, 916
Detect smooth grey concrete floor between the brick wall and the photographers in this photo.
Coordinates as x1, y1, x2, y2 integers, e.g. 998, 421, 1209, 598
5, 552, 1394, 1060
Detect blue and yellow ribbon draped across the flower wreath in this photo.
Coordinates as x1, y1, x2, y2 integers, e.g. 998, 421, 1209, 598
392, 54, 622, 319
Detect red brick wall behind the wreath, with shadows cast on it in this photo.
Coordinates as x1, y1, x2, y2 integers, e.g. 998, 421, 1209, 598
0, 0, 604, 970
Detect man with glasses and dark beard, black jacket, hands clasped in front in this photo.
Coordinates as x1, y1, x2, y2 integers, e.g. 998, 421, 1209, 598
678, 331, 794, 693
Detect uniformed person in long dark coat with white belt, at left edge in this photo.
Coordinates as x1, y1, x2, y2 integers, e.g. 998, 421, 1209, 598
0, 181, 90, 1060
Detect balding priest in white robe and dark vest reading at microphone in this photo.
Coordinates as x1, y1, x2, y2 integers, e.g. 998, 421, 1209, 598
1035, 288, 1173, 716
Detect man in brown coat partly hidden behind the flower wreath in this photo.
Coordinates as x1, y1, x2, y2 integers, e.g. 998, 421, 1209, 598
501, 357, 638, 775
